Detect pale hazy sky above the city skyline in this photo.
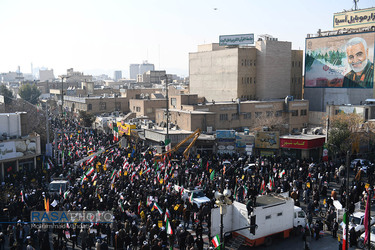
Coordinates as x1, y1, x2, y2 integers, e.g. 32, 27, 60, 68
0, 0, 375, 77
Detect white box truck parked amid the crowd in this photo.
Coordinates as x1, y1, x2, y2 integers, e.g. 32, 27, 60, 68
211, 194, 306, 246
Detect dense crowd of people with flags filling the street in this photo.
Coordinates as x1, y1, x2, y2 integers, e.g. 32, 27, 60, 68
0, 116, 372, 250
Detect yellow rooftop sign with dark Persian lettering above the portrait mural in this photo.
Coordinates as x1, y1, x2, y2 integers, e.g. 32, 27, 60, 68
333, 8, 375, 30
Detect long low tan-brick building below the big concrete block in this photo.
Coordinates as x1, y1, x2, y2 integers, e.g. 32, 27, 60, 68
155, 95, 309, 133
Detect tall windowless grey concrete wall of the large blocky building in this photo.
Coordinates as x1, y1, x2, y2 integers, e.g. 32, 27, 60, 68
256, 40, 292, 100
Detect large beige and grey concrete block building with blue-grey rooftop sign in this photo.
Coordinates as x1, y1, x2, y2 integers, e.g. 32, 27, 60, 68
189, 37, 303, 102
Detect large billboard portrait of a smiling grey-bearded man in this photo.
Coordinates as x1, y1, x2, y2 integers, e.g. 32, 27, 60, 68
305, 32, 375, 88
